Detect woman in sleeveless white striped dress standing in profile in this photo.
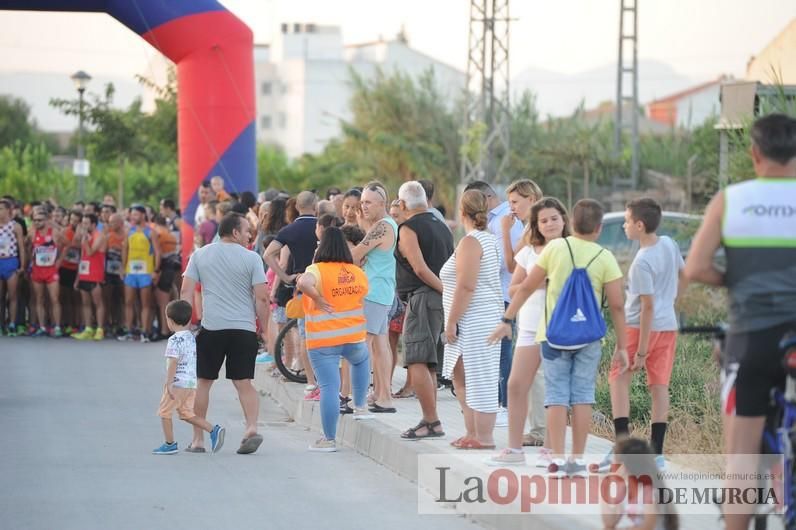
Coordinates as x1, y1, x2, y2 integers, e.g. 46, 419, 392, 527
439, 190, 503, 449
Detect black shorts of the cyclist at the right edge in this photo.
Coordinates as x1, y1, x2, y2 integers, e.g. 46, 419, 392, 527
726, 322, 796, 417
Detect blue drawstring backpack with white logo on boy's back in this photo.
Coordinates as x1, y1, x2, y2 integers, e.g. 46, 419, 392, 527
545, 238, 606, 350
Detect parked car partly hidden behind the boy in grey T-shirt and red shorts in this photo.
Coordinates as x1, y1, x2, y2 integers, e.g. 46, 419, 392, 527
597, 211, 702, 262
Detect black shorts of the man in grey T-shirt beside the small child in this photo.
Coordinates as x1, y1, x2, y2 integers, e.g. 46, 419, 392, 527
196, 328, 257, 381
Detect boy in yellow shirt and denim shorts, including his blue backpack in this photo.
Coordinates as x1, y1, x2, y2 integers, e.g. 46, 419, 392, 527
490, 199, 628, 478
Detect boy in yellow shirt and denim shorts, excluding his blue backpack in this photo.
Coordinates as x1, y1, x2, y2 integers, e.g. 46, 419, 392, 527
490, 199, 628, 478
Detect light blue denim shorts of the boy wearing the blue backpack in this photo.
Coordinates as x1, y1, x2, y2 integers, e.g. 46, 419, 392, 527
542, 340, 602, 407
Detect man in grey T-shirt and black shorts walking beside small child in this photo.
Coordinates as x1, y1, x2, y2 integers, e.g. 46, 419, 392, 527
180, 213, 270, 454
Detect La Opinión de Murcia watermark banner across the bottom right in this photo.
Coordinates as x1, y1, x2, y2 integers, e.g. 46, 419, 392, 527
418, 455, 784, 516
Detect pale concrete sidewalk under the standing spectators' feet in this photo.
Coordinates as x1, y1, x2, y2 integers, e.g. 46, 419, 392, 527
255, 365, 716, 530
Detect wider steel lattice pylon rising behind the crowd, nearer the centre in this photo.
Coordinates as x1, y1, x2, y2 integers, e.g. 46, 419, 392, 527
461, 0, 510, 184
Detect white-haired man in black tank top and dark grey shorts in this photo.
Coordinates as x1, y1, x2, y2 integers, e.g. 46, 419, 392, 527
395, 181, 453, 439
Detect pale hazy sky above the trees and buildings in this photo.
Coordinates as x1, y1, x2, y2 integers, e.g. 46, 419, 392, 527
0, 0, 796, 82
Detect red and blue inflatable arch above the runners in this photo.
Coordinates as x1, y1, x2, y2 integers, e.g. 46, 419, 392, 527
0, 0, 257, 260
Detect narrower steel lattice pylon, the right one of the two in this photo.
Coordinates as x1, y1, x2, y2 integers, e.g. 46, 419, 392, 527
613, 0, 640, 190
